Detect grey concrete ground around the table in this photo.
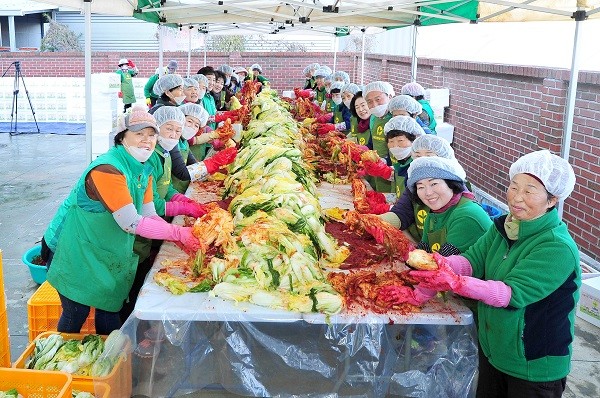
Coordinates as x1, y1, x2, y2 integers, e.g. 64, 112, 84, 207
0, 133, 600, 398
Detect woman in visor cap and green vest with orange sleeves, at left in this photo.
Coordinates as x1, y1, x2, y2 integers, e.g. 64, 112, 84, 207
44, 106, 200, 334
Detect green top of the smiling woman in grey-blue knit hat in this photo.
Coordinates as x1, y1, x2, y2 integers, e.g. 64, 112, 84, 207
422, 197, 492, 253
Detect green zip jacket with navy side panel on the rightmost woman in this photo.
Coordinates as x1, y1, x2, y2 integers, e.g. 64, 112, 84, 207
464, 209, 581, 382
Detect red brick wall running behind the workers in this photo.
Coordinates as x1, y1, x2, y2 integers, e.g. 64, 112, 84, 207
0, 52, 600, 260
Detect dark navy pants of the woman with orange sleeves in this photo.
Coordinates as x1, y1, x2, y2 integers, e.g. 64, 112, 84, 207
57, 293, 122, 334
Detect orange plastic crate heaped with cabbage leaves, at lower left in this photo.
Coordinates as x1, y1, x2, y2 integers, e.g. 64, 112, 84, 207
13, 332, 132, 398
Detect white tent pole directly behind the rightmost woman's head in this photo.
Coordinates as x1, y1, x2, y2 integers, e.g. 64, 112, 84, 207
557, 11, 587, 219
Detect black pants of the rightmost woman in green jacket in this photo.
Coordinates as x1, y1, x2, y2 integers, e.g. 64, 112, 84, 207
477, 348, 567, 398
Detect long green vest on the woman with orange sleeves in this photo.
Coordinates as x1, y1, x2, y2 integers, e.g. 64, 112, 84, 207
48, 145, 146, 312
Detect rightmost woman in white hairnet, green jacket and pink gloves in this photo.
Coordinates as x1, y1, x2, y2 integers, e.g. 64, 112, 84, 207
411, 150, 581, 398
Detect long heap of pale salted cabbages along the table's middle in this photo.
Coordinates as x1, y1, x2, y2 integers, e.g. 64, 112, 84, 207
208, 89, 349, 314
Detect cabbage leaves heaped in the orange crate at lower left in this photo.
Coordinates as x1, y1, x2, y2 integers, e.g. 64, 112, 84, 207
25, 330, 127, 377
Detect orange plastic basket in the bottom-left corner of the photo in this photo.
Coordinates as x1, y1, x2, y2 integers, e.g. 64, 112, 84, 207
0, 368, 72, 398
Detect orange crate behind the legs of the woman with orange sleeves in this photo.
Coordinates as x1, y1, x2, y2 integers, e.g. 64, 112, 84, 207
27, 281, 96, 342
